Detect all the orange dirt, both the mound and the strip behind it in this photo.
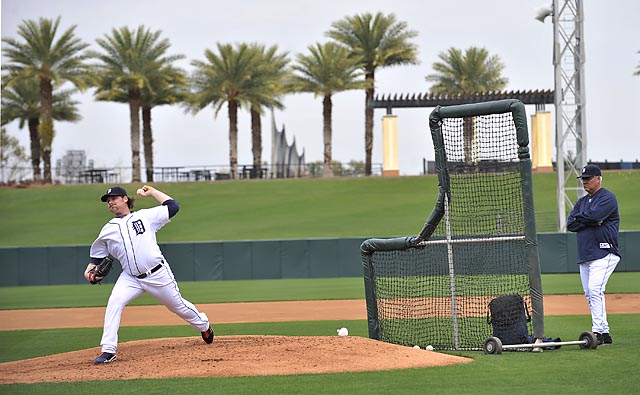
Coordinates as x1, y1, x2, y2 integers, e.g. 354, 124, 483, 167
0, 294, 640, 384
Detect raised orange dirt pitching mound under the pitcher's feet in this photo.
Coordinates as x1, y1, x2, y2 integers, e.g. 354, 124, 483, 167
0, 336, 471, 384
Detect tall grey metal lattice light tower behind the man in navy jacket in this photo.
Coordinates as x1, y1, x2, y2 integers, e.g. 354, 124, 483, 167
535, 0, 587, 232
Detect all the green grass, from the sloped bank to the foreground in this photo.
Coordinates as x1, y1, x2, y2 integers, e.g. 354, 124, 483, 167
0, 172, 640, 395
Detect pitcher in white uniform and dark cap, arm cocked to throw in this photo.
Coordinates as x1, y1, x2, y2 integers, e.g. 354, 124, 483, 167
84, 185, 214, 364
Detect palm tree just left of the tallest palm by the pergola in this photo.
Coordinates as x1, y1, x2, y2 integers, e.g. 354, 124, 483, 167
290, 42, 371, 177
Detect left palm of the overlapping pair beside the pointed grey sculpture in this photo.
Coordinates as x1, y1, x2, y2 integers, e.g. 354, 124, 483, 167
188, 43, 261, 179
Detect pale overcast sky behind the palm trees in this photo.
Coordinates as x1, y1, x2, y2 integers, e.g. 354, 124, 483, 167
1, 0, 640, 175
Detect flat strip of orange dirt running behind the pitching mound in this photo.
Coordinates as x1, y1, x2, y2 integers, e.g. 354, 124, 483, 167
0, 294, 640, 331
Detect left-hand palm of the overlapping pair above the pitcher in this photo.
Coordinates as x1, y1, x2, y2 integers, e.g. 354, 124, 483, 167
89, 25, 183, 182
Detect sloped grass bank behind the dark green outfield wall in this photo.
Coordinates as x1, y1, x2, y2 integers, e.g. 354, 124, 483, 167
0, 171, 640, 246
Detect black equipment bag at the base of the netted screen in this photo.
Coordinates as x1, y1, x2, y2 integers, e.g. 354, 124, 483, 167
487, 295, 531, 344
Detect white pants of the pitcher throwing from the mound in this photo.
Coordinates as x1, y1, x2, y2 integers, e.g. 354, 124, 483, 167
100, 262, 209, 354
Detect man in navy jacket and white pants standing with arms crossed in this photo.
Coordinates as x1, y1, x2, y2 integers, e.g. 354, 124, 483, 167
567, 165, 620, 344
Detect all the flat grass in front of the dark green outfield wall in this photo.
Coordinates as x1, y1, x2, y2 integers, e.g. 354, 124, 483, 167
0, 273, 640, 394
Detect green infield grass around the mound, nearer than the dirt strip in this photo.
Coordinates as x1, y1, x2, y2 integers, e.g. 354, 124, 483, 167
0, 315, 640, 395
